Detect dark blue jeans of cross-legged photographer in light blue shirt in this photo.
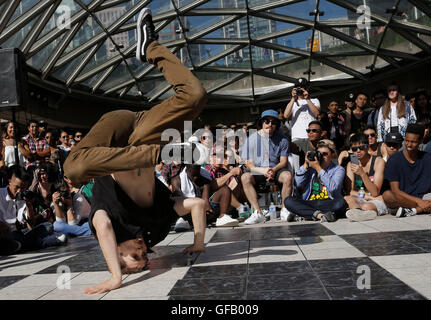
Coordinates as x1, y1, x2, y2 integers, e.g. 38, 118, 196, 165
284, 197, 347, 219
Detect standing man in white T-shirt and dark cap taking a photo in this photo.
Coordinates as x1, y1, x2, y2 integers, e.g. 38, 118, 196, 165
284, 78, 320, 141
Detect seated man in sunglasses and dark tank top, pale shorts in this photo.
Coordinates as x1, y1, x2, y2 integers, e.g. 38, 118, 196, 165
344, 134, 388, 221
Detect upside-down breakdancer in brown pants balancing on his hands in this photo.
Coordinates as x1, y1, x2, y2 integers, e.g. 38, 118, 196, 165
64, 8, 208, 294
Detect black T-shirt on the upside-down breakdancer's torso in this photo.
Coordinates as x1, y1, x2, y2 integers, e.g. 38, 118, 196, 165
88, 175, 178, 248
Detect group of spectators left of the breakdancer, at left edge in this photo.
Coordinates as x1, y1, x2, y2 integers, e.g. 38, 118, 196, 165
0, 120, 91, 255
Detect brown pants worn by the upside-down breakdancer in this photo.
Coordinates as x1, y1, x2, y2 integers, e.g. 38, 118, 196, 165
64, 41, 207, 185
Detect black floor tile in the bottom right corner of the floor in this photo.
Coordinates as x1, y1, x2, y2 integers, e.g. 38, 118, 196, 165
326, 285, 425, 300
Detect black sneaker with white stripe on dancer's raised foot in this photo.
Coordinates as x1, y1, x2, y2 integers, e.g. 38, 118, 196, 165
136, 8, 159, 62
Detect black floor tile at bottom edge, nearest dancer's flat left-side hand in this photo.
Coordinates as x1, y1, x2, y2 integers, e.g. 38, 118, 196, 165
169, 277, 246, 296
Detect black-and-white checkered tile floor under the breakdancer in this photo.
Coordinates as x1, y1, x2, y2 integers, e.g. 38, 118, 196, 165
0, 215, 431, 300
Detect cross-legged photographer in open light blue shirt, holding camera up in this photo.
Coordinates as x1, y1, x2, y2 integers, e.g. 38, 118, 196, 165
283, 140, 346, 222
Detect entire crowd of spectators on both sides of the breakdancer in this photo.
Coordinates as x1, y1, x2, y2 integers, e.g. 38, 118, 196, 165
0, 78, 431, 254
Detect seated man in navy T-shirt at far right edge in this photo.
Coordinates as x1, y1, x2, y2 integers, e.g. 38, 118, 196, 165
383, 124, 431, 218
